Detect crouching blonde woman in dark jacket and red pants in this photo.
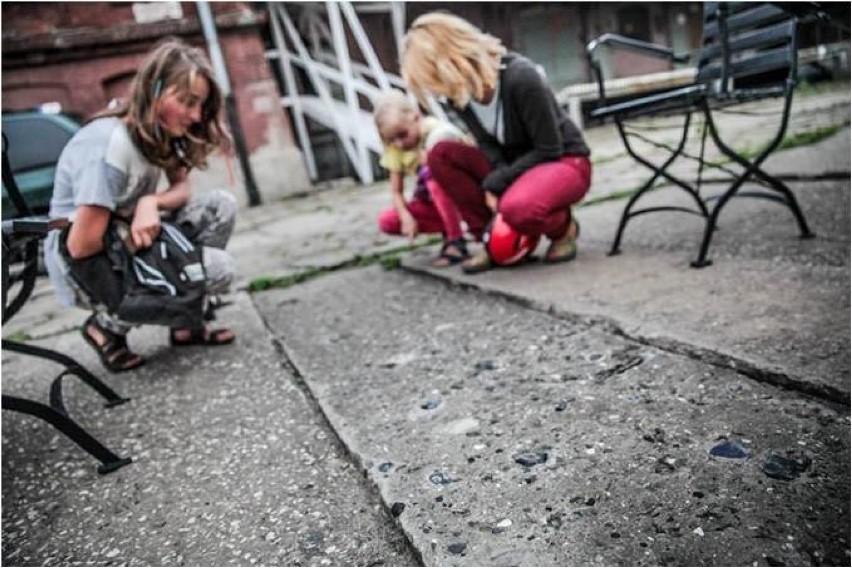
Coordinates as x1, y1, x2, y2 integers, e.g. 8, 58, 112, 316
402, 12, 592, 273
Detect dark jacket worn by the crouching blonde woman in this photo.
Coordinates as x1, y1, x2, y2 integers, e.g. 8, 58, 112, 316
455, 53, 589, 195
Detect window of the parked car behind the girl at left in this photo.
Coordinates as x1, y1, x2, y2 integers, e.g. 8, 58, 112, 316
3, 117, 73, 173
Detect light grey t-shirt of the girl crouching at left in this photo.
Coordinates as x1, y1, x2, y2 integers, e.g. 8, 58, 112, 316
44, 117, 162, 306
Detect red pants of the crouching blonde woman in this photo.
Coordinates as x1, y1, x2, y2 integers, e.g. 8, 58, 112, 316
428, 141, 592, 239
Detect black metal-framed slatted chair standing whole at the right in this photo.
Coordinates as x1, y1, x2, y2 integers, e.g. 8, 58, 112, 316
587, 2, 814, 268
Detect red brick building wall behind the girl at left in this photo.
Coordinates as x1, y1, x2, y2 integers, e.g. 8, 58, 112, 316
2, 2, 309, 203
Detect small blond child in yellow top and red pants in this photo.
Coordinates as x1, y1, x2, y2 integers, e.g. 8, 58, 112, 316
373, 89, 470, 267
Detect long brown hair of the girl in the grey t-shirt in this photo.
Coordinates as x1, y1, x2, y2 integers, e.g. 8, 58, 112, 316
98, 38, 228, 171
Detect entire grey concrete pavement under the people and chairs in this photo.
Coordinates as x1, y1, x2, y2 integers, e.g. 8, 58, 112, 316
3, 80, 850, 565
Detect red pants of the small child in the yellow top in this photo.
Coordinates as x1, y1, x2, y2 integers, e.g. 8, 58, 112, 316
379, 179, 462, 241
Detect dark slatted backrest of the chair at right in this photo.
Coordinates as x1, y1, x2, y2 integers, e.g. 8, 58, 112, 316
696, 2, 797, 94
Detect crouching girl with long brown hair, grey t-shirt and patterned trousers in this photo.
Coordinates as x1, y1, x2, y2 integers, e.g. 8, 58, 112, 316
45, 40, 236, 372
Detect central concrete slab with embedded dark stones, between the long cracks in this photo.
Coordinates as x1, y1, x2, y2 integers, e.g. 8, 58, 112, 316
257, 268, 849, 566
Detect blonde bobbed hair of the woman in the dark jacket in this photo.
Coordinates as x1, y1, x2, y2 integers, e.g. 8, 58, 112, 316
401, 12, 506, 108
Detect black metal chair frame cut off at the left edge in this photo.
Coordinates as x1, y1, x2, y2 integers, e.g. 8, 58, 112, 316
0, 134, 133, 474
